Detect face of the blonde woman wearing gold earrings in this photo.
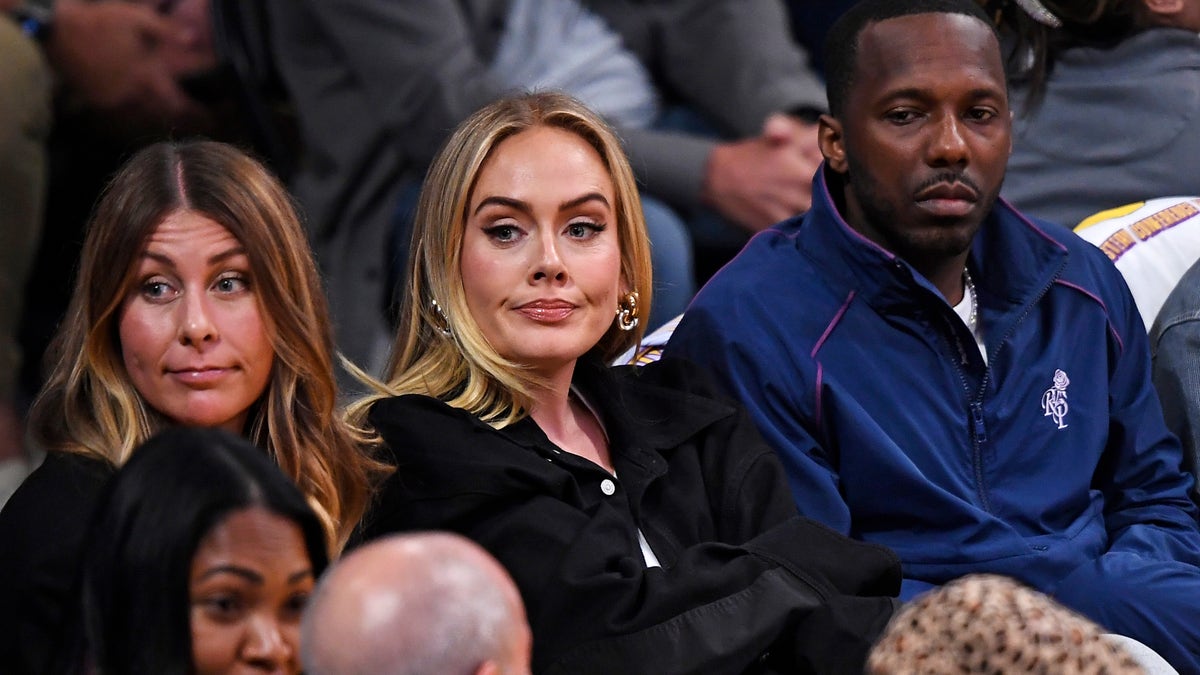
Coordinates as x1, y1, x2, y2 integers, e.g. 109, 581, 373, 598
462, 127, 622, 376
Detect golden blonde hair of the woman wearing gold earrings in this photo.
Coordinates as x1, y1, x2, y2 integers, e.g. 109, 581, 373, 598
349, 91, 653, 428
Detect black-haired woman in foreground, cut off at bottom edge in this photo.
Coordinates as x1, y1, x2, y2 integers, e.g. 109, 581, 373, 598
60, 428, 329, 675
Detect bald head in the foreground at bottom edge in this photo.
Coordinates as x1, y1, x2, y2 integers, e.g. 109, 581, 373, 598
301, 532, 533, 675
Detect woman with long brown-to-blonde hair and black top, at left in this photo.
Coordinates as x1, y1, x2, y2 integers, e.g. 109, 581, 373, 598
0, 142, 382, 671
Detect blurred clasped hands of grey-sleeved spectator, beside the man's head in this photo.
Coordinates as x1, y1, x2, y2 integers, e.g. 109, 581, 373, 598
703, 114, 821, 232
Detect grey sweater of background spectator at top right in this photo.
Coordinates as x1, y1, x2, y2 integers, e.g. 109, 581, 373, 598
1002, 28, 1200, 227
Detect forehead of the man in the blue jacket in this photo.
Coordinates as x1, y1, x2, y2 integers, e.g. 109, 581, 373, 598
854, 13, 1006, 95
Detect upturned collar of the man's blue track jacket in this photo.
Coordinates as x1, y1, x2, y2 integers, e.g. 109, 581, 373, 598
782, 165, 1067, 312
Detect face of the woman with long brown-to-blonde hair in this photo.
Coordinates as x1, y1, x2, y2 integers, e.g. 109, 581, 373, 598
118, 211, 275, 434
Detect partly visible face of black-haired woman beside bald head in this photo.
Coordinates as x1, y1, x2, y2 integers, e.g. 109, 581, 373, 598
187, 507, 314, 675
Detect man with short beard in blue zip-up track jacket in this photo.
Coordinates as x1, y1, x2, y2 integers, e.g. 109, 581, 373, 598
666, 0, 1200, 673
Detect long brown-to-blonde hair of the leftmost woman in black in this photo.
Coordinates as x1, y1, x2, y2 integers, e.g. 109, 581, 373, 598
30, 141, 386, 551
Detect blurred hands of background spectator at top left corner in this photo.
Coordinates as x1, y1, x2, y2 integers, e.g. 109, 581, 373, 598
47, 0, 199, 121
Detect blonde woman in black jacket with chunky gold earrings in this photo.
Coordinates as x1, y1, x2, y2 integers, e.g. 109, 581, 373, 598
353, 92, 899, 673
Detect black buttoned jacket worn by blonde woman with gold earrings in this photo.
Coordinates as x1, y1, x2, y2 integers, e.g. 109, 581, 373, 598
365, 362, 900, 674
